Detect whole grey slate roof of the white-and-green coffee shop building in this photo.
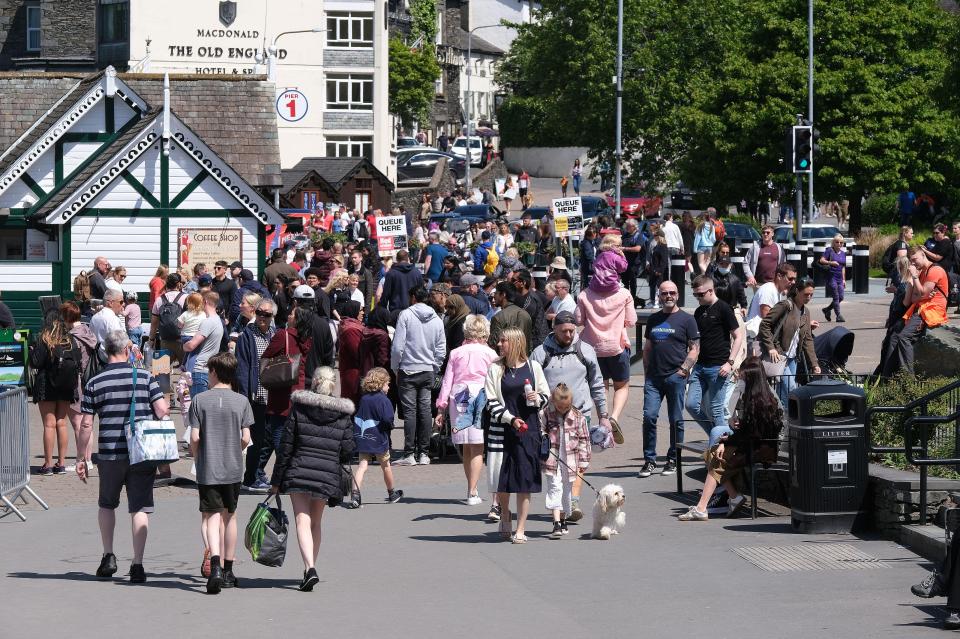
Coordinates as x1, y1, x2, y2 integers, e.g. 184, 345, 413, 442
0, 72, 282, 188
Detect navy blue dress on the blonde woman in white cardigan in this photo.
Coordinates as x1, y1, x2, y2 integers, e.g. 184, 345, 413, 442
497, 362, 541, 493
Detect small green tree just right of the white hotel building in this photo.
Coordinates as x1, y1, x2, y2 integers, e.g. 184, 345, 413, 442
390, 38, 440, 125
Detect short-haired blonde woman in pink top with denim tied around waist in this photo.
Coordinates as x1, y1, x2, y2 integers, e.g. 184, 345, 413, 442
436, 315, 499, 506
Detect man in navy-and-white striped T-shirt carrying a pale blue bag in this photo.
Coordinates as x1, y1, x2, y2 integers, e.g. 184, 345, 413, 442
77, 331, 170, 583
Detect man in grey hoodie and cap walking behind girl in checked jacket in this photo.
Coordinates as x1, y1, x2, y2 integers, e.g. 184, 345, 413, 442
530, 311, 612, 521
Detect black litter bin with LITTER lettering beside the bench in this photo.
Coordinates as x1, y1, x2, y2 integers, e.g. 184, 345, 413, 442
787, 379, 867, 533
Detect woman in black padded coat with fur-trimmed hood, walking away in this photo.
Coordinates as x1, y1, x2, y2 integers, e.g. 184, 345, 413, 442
270, 366, 356, 592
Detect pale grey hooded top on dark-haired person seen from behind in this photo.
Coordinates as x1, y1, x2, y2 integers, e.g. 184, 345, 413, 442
390, 303, 447, 374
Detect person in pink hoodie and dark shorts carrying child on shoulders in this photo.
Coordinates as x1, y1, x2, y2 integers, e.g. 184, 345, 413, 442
575, 248, 637, 444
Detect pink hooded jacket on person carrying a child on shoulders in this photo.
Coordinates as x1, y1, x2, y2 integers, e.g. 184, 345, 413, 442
575, 288, 637, 357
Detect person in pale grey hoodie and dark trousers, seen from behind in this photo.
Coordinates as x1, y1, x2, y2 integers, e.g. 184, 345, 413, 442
390, 286, 447, 466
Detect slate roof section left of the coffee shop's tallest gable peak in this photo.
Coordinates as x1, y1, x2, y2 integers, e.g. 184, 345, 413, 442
0, 73, 103, 174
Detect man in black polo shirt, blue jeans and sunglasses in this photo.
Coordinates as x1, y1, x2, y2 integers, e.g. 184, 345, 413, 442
687, 275, 746, 446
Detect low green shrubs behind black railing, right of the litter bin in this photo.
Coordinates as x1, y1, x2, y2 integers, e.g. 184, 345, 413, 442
867, 373, 960, 478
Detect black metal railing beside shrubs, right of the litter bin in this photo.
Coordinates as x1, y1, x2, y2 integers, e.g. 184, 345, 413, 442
864, 380, 960, 525
